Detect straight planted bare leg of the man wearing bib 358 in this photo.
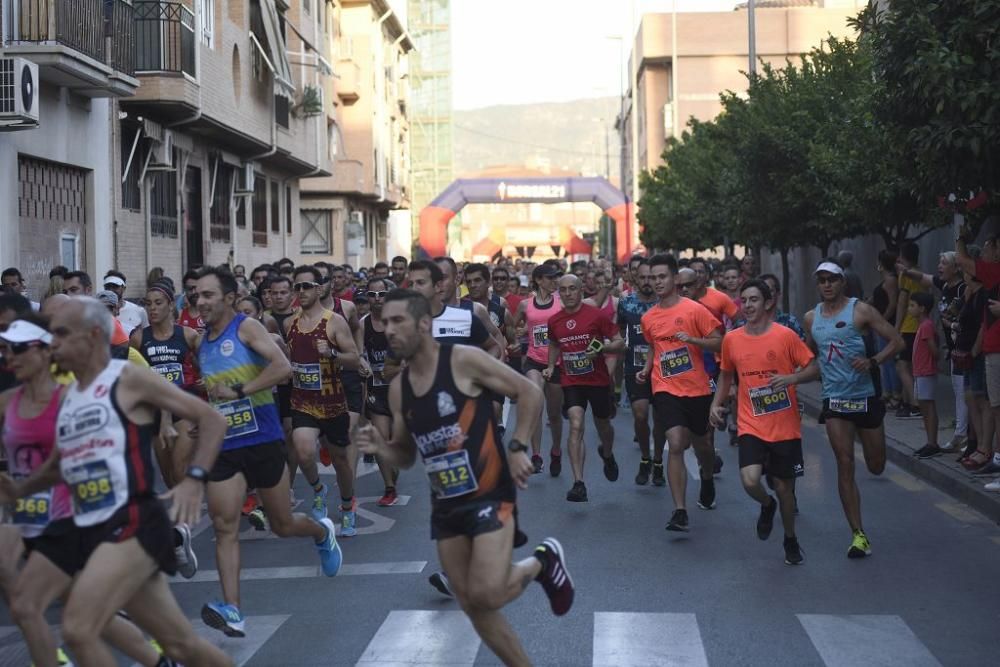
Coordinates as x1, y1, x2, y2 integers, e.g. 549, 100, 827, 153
205, 473, 247, 607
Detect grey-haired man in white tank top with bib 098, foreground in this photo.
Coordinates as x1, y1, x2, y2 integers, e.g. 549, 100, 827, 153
3, 297, 232, 665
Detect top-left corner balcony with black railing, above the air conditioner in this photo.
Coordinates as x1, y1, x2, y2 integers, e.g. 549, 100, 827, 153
3, 0, 139, 97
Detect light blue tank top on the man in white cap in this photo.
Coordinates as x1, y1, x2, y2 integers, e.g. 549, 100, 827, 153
812, 299, 876, 398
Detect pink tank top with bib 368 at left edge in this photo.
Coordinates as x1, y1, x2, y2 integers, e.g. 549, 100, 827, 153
3, 387, 73, 538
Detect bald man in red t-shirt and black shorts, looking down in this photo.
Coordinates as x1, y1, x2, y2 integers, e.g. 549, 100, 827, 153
542, 274, 625, 503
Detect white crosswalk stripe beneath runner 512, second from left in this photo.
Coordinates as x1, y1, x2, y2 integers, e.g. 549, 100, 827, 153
357, 611, 480, 667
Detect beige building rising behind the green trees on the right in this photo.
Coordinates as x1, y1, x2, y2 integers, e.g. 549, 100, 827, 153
616, 0, 864, 209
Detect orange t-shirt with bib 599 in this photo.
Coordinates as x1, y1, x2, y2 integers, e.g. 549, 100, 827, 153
640, 297, 722, 396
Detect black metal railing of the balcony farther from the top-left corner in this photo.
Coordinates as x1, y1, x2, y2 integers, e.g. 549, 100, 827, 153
132, 0, 197, 77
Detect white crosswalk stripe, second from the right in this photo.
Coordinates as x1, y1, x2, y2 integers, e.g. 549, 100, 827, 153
593, 612, 708, 667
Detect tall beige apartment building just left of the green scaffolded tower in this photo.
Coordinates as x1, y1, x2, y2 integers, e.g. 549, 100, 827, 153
298, 0, 413, 267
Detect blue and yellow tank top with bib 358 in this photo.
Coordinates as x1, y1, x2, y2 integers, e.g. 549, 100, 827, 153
198, 313, 285, 451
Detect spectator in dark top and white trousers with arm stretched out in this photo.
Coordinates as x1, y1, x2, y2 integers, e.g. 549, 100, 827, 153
905, 250, 969, 451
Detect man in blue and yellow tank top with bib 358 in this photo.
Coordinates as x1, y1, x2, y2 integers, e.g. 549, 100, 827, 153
198, 267, 342, 637
